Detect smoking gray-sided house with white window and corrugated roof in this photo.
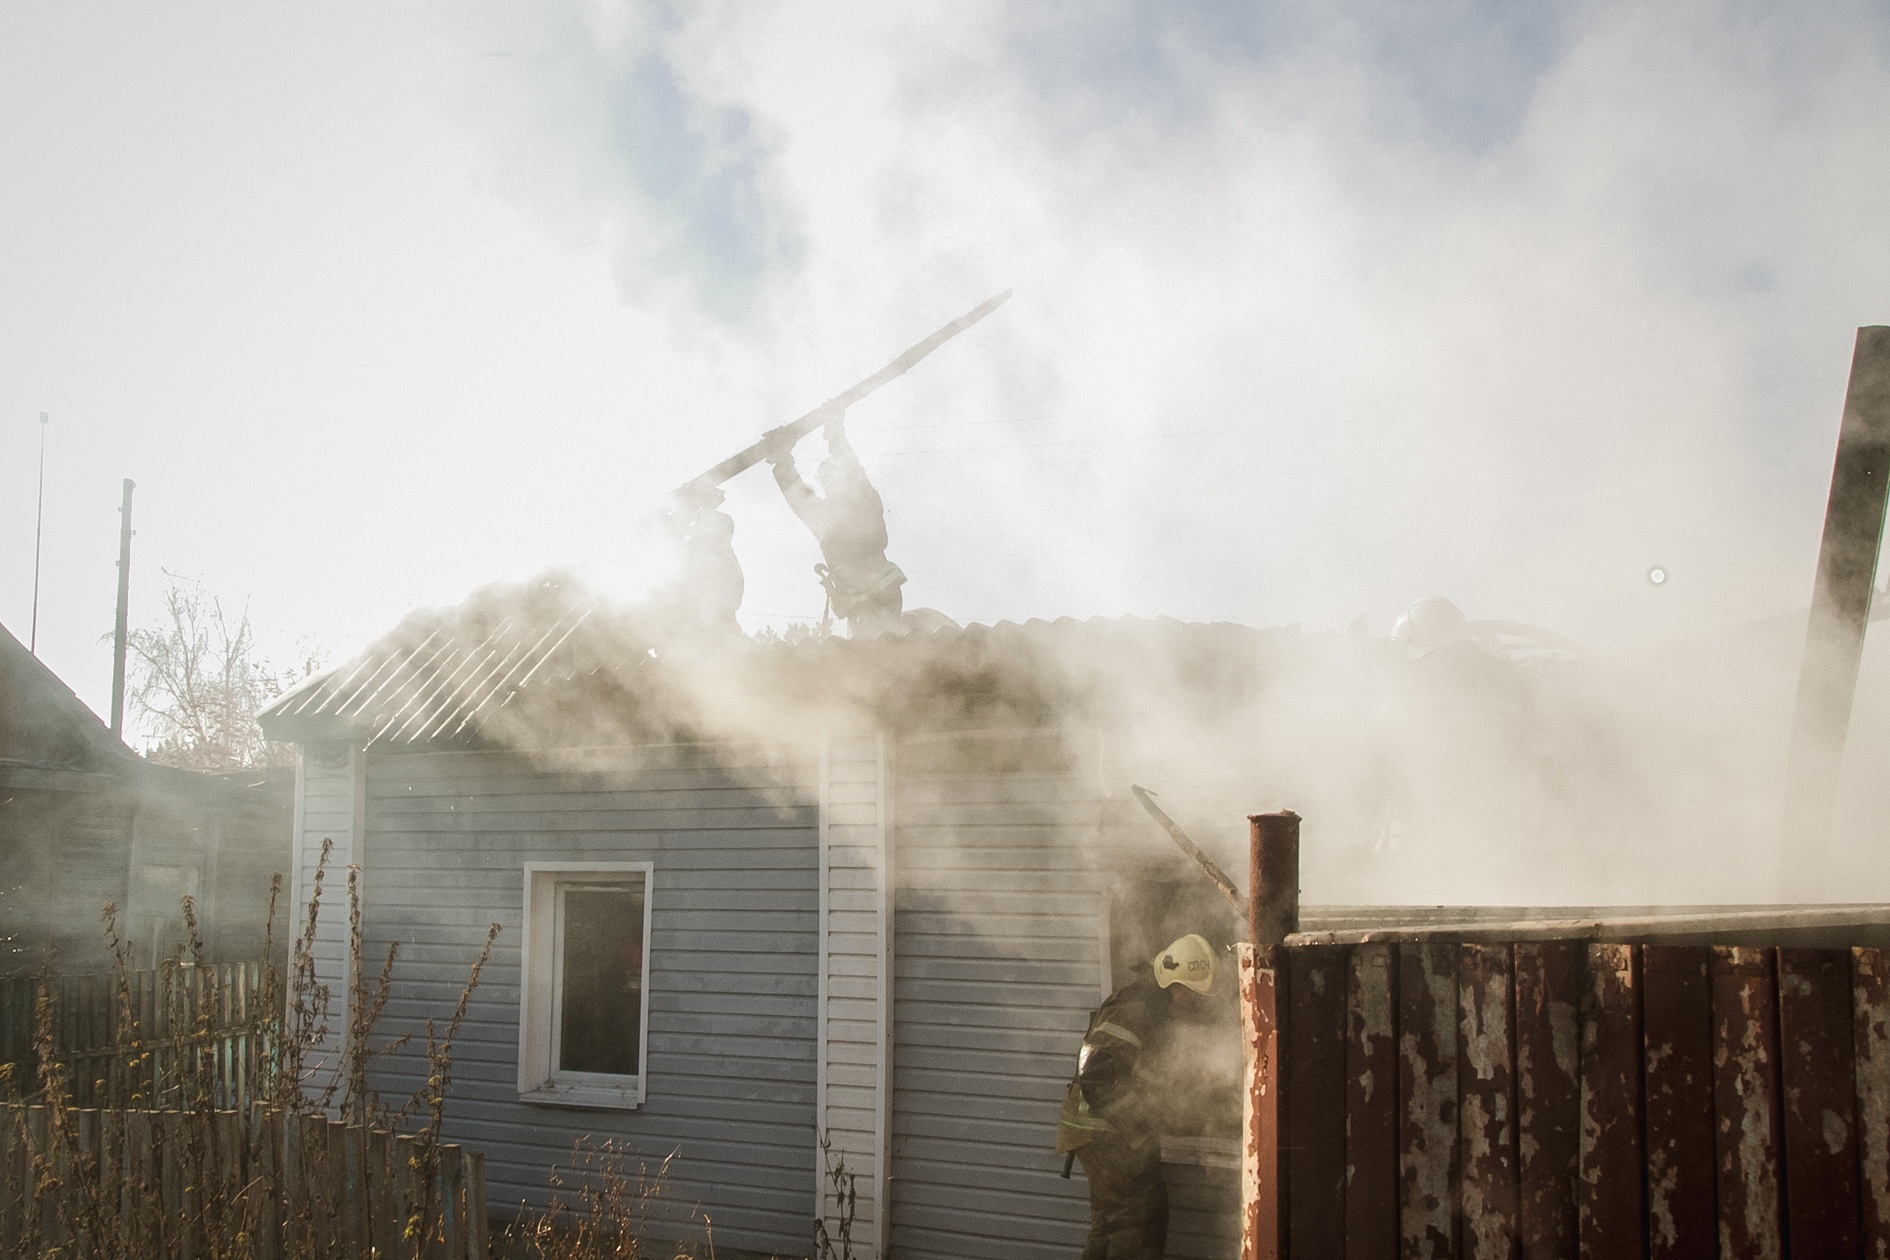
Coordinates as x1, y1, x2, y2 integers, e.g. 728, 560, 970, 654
263, 578, 1421, 1258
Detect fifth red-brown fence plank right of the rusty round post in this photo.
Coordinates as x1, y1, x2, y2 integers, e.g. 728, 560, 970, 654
1514, 941, 1586, 1260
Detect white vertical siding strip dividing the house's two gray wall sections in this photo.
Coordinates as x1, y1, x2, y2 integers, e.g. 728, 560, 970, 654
816, 735, 890, 1260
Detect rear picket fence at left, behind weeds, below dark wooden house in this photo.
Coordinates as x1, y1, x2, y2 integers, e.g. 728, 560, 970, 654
0, 962, 276, 1111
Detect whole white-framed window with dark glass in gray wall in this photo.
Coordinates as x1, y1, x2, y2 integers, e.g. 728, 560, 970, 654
518, 861, 652, 1107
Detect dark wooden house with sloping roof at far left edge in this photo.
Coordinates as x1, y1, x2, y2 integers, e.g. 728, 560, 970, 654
0, 627, 293, 975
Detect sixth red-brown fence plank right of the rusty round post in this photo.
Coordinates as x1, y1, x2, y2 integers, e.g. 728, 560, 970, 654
1576, 945, 1646, 1260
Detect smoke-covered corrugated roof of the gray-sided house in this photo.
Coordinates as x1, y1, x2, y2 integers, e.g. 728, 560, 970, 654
261, 576, 1389, 748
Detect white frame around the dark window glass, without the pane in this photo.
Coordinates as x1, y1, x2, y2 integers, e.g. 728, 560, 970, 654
518, 861, 656, 1111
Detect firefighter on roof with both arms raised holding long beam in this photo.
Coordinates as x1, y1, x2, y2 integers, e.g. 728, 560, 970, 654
767, 412, 905, 637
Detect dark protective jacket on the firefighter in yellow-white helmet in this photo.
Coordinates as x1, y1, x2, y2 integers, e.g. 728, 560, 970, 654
1057, 967, 1172, 1152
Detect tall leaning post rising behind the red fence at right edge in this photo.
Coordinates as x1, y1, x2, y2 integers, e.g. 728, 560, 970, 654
1778, 325, 1890, 901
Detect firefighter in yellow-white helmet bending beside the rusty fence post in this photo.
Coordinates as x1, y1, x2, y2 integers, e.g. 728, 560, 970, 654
1057, 933, 1217, 1260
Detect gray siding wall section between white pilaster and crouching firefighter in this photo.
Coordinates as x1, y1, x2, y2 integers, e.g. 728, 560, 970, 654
892, 741, 1102, 1260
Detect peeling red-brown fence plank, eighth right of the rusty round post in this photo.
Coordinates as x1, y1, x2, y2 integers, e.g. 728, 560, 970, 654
1712, 945, 1784, 1260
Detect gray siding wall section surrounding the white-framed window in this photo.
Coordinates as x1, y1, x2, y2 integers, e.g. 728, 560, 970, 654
353, 746, 818, 1256
